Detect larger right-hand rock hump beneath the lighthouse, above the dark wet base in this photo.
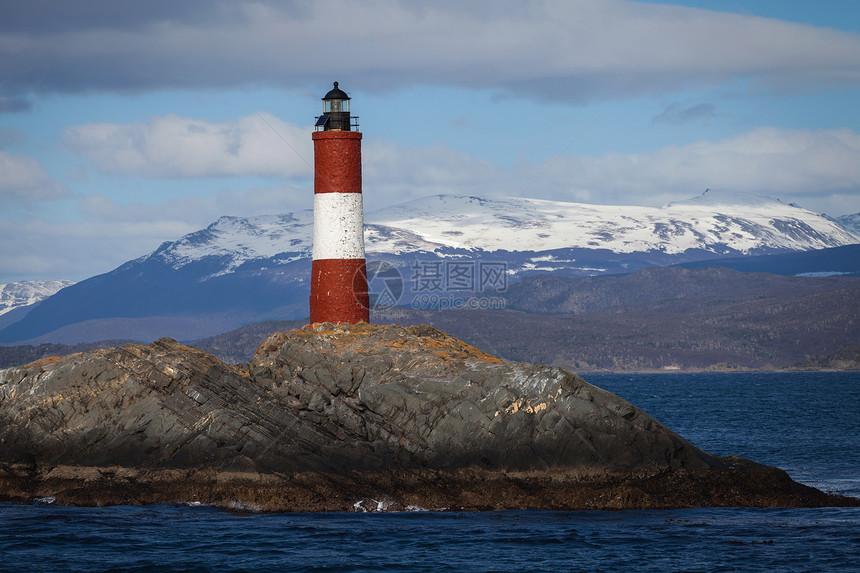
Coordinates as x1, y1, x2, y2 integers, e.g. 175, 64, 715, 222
252, 325, 713, 470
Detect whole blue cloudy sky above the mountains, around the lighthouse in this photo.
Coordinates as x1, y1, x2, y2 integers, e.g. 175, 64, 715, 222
0, 0, 860, 283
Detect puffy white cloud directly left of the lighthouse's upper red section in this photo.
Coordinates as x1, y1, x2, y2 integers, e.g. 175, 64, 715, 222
63, 114, 313, 179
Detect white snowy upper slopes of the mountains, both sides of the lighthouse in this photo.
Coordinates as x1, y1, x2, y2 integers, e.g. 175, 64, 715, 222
138, 192, 860, 276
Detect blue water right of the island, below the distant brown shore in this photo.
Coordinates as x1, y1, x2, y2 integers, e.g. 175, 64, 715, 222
586, 372, 860, 496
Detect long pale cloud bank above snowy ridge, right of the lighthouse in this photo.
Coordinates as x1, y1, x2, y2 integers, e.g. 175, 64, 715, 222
364, 127, 860, 214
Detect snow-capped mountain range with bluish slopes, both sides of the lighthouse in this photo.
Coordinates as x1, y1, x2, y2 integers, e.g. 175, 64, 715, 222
0, 193, 860, 343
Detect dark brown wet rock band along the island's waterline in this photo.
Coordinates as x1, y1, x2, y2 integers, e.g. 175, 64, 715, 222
0, 458, 860, 513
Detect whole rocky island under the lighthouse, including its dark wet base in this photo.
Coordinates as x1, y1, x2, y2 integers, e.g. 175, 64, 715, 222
0, 323, 860, 511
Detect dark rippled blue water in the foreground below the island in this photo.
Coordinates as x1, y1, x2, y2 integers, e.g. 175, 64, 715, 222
0, 506, 860, 572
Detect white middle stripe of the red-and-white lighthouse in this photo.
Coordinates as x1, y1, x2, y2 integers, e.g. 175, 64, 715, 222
313, 193, 364, 260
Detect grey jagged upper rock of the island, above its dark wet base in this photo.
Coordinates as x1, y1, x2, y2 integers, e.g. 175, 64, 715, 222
0, 324, 724, 474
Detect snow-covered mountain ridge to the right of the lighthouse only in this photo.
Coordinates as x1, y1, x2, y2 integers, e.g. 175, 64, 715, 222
367, 192, 860, 255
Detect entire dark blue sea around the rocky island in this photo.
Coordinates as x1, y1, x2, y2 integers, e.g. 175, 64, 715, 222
0, 372, 860, 573
